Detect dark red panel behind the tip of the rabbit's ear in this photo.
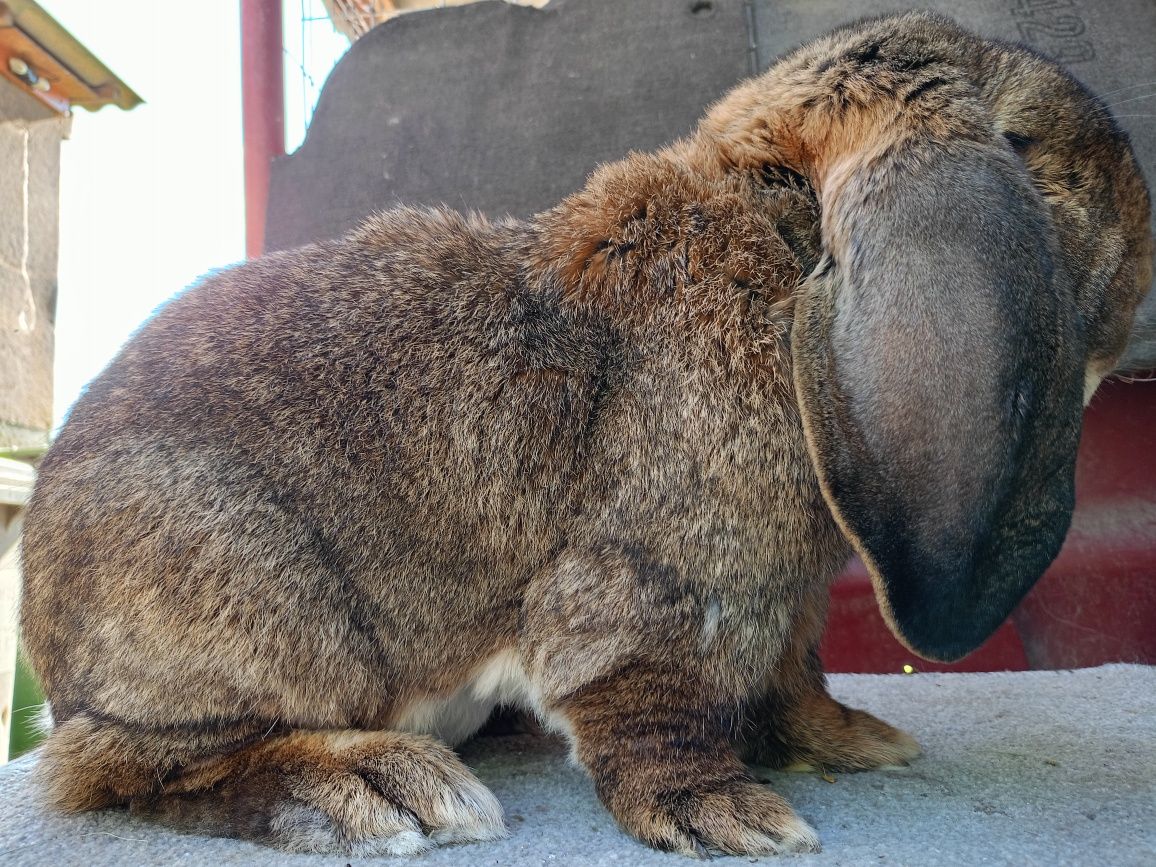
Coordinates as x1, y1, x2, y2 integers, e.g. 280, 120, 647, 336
822, 381, 1156, 673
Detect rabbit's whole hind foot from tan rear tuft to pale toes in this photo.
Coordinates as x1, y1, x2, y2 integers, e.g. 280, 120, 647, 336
37, 713, 506, 857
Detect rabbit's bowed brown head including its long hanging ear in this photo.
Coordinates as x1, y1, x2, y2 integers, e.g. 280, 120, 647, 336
683, 13, 1153, 660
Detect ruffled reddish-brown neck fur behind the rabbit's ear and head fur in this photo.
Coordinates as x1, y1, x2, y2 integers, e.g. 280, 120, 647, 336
527, 153, 818, 379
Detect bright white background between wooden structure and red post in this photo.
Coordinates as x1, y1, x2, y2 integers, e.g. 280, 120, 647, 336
47, 0, 245, 423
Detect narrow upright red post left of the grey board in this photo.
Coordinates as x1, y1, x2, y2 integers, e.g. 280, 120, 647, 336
240, 0, 286, 257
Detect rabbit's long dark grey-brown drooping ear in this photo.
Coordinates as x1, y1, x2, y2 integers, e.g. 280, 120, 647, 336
792, 140, 1083, 660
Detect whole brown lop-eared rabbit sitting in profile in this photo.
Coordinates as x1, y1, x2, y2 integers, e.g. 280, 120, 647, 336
13, 14, 1153, 855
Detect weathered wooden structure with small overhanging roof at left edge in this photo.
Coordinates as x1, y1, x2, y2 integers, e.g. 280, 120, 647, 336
0, 0, 140, 764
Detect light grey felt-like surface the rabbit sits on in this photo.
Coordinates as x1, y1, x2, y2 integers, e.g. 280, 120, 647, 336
0, 666, 1156, 867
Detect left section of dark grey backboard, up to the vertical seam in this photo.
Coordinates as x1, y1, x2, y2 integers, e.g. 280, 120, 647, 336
266, 0, 754, 250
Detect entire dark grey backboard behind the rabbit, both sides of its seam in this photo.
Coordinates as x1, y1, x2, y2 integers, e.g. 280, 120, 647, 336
266, 0, 1156, 250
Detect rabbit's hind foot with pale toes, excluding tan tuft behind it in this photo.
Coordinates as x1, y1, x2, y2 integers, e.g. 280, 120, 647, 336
131, 731, 506, 857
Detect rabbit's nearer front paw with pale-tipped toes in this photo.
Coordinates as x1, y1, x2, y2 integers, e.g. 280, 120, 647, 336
614, 780, 820, 858
